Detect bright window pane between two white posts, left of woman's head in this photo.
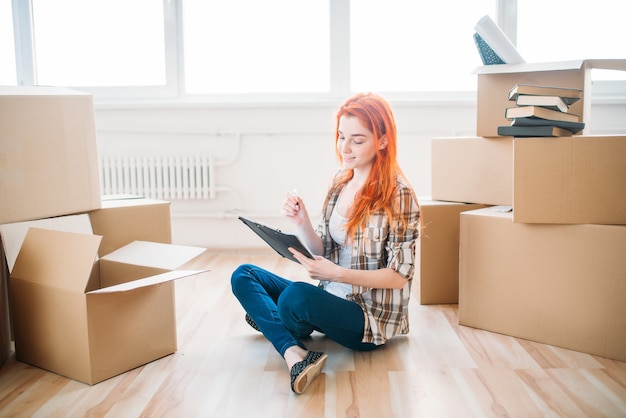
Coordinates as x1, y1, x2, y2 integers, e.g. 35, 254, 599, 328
183, 0, 330, 94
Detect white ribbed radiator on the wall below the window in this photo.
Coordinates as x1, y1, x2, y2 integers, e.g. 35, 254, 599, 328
100, 155, 216, 200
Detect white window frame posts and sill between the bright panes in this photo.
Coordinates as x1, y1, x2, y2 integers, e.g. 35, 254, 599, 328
12, 0, 626, 103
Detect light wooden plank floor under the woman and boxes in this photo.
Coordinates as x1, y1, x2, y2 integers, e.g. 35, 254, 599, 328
0, 251, 626, 418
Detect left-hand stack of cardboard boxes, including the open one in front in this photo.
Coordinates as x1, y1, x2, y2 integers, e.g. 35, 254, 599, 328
0, 87, 204, 384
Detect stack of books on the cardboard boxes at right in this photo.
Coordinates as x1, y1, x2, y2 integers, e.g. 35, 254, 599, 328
498, 84, 585, 137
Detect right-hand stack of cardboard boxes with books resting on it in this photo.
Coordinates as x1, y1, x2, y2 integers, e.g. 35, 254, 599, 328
424, 60, 626, 361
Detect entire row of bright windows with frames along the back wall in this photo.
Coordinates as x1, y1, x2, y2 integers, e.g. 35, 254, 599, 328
6, 0, 626, 100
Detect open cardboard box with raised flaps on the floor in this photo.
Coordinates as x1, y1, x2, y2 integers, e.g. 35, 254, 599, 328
10, 228, 204, 384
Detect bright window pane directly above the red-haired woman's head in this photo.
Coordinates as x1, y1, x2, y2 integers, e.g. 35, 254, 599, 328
350, 0, 495, 92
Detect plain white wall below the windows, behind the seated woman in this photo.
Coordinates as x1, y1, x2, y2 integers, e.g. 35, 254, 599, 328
96, 101, 626, 248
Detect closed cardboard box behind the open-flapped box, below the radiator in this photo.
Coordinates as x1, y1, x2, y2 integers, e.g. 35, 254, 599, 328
89, 196, 172, 257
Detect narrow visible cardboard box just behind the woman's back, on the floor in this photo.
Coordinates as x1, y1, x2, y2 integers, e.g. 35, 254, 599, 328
417, 199, 485, 305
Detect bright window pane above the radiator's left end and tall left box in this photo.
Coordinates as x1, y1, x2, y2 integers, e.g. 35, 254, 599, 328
32, 0, 165, 86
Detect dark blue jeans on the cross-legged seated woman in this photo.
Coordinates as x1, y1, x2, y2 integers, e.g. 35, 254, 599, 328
231, 264, 378, 357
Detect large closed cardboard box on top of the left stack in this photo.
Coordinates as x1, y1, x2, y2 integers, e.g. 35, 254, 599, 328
0, 87, 100, 224
